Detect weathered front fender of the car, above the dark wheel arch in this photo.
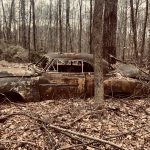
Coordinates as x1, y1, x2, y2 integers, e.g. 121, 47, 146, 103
0, 76, 40, 101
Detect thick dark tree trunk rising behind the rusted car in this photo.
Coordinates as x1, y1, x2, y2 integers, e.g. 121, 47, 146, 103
103, 0, 118, 64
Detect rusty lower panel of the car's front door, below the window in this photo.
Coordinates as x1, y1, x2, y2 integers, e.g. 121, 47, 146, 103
39, 73, 85, 99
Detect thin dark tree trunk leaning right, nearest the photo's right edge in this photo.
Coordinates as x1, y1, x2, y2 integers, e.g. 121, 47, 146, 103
140, 0, 148, 63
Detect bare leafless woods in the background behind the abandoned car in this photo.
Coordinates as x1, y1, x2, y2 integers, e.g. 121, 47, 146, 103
0, 0, 150, 62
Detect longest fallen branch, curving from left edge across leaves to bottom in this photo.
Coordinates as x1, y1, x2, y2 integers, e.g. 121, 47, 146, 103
0, 113, 126, 150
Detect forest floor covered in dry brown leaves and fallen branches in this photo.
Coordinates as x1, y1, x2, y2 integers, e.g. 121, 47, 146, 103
0, 99, 150, 150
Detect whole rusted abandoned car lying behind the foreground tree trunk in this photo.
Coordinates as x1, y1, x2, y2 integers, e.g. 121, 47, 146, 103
0, 53, 147, 101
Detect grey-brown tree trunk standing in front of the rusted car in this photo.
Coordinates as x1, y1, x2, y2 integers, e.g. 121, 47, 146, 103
92, 0, 104, 108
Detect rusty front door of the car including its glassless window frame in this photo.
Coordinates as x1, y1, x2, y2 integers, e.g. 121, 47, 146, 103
39, 59, 86, 100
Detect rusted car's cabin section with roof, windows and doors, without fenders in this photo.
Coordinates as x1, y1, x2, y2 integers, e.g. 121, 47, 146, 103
36, 53, 111, 99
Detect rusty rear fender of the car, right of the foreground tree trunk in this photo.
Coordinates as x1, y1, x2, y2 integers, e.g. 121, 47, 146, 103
104, 77, 150, 97
